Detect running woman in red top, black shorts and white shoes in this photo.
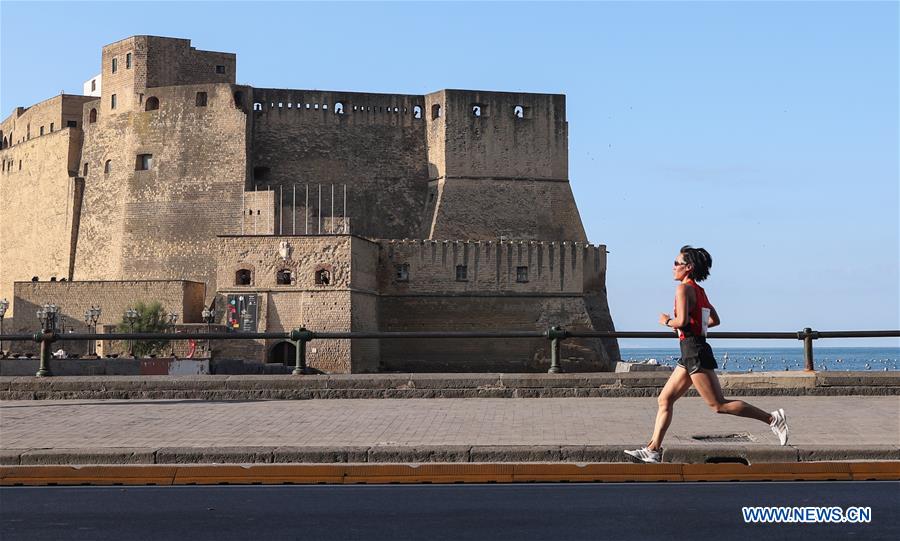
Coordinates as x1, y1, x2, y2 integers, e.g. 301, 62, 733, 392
625, 246, 788, 462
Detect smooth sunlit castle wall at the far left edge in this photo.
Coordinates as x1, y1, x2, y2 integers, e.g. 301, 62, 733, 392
0, 128, 83, 316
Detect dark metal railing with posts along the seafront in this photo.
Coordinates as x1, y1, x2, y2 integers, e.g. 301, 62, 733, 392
0, 326, 900, 377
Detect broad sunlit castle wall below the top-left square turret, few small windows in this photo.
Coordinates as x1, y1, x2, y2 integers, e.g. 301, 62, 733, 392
75, 85, 246, 300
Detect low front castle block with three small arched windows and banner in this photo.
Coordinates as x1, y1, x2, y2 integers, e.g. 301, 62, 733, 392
216, 235, 379, 372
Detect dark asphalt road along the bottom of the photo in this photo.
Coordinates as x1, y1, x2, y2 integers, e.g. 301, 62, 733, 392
0, 481, 900, 541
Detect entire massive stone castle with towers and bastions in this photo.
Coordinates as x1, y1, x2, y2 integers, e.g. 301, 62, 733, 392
0, 36, 619, 372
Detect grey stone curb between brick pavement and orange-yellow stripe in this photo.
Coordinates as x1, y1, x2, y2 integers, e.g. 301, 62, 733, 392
0, 443, 900, 466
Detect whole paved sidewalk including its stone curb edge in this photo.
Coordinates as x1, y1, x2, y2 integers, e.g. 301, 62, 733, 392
0, 396, 900, 464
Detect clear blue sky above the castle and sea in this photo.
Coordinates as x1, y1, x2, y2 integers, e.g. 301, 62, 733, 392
0, 1, 900, 347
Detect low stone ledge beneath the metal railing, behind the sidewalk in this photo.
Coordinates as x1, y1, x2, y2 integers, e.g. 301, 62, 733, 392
0, 372, 900, 400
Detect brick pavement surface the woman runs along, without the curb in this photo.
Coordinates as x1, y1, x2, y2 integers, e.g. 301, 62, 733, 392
0, 396, 900, 451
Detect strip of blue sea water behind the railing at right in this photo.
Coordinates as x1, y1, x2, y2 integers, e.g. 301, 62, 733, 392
620, 342, 900, 372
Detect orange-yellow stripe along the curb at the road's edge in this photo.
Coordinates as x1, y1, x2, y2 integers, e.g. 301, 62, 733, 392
0, 461, 900, 486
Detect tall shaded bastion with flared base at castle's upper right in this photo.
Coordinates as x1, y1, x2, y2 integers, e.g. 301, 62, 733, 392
426, 90, 587, 242
